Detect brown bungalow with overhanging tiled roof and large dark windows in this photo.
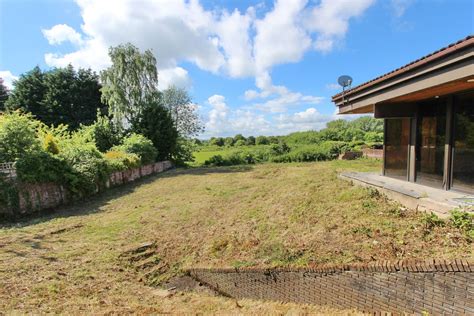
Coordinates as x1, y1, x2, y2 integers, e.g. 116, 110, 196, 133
332, 36, 474, 195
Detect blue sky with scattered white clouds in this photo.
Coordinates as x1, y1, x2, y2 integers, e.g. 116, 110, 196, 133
0, 0, 474, 137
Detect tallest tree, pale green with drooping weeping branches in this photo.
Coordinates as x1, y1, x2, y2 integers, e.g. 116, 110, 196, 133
101, 43, 159, 127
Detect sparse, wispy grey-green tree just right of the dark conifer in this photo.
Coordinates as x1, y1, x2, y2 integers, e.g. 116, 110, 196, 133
163, 86, 204, 137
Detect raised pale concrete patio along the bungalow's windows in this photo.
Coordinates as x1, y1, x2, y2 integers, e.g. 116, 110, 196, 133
340, 172, 474, 217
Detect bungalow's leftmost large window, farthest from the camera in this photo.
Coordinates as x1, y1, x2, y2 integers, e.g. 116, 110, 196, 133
385, 118, 410, 180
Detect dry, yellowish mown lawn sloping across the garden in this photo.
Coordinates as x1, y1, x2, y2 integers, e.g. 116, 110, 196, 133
0, 160, 473, 315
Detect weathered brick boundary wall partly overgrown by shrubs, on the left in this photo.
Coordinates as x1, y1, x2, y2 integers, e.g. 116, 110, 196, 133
0, 161, 173, 217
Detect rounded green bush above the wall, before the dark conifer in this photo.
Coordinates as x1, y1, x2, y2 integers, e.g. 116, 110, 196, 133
112, 134, 158, 165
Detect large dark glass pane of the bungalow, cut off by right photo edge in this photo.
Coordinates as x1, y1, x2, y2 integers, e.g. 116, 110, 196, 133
452, 92, 474, 193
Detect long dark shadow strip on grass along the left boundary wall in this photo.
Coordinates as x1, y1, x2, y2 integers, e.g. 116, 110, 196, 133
0, 165, 253, 229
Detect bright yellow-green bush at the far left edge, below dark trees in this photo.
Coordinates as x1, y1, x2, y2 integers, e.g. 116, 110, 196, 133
0, 111, 40, 162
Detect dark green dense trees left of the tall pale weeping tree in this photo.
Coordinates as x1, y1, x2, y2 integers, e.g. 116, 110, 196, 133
6, 65, 105, 130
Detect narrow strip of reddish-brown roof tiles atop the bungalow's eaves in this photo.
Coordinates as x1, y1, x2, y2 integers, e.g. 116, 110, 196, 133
332, 35, 474, 101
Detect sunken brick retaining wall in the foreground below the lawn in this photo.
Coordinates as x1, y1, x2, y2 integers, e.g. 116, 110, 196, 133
188, 260, 474, 315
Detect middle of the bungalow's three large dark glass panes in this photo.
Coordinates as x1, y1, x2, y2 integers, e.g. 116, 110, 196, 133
416, 99, 446, 188
